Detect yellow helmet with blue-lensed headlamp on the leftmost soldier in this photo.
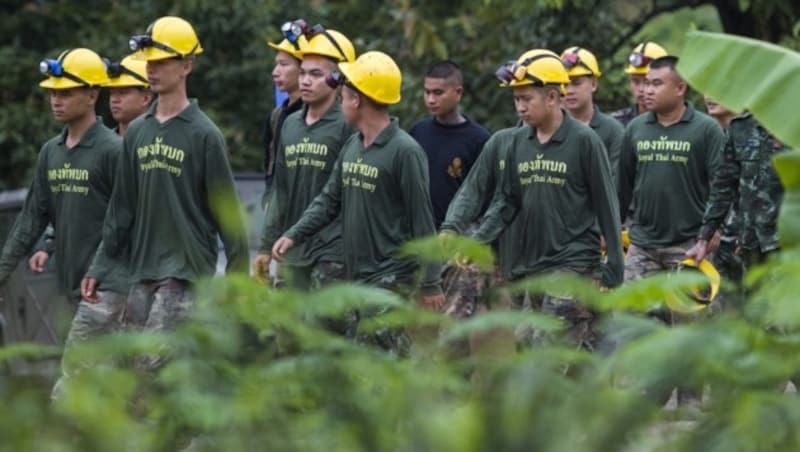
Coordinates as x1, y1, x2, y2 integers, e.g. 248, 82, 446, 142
39, 48, 109, 89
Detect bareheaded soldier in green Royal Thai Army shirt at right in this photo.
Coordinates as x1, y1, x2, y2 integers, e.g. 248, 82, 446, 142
619, 56, 725, 300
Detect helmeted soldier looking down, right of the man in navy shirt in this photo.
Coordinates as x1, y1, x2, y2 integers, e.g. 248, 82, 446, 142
475, 49, 623, 350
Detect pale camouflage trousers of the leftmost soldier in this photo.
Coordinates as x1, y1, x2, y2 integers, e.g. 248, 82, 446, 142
51, 290, 127, 400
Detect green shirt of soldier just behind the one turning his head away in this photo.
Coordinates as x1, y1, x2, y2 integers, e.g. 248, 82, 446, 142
261, 102, 353, 266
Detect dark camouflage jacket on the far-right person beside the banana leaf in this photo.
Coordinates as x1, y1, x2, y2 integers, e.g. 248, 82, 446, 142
698, 113, 787, 266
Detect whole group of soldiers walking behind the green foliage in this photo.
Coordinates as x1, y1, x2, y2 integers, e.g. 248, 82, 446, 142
0, 16, 784, 396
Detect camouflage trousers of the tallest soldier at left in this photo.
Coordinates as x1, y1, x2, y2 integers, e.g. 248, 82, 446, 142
124, 278, 194, 371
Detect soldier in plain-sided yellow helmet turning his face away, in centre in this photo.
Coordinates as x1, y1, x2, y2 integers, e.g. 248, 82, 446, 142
272, 51, 444, 355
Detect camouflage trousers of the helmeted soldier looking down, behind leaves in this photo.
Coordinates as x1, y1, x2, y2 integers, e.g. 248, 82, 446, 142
511, 268, 598, 351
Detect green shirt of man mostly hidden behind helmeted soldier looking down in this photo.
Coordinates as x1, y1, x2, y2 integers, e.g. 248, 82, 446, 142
441, 127, 521, 278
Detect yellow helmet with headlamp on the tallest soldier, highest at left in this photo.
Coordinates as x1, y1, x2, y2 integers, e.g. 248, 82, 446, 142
128, 16, 203, 61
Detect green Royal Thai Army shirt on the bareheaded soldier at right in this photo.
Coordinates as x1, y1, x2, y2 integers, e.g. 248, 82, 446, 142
619, 104, 725, 248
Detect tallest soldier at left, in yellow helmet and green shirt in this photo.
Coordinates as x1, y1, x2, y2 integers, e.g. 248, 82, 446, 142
82, 16, 248, 369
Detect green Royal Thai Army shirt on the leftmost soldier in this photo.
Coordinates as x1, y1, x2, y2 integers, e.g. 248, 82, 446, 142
0, 118, 129, 297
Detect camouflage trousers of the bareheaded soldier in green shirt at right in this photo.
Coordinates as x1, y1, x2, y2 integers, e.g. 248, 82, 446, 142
625, 239, 706, 325
